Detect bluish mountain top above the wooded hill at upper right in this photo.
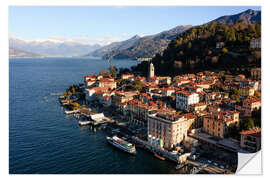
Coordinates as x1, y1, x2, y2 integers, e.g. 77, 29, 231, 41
209, 9, 261, 24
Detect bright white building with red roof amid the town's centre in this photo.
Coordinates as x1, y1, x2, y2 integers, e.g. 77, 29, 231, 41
176, 91, 200, 110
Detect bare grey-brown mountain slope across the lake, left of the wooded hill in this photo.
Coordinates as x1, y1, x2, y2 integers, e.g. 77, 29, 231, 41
87, 25, 192, 59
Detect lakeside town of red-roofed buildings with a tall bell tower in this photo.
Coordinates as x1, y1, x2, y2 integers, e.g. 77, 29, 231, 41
72, 58, 261, 172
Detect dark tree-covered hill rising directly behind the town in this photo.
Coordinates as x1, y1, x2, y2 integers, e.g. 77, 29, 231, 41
133, 20, 261, 76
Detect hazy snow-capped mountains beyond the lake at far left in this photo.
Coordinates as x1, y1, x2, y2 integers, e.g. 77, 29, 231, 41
9, 38, 101, 57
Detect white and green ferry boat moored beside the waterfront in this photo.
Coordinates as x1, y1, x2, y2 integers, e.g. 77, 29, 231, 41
107, 136, 136, 155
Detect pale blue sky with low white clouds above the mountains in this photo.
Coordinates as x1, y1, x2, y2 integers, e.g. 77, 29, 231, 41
9, 6, 261, 45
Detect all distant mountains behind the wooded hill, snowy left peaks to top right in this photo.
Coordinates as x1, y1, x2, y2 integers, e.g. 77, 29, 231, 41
9, 9, 261, 59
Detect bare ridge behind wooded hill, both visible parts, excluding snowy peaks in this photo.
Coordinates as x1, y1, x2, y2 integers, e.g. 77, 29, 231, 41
87, 9, 261, 59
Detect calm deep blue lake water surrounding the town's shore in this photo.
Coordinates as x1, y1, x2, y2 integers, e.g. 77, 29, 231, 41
9, 58, 180, 174
